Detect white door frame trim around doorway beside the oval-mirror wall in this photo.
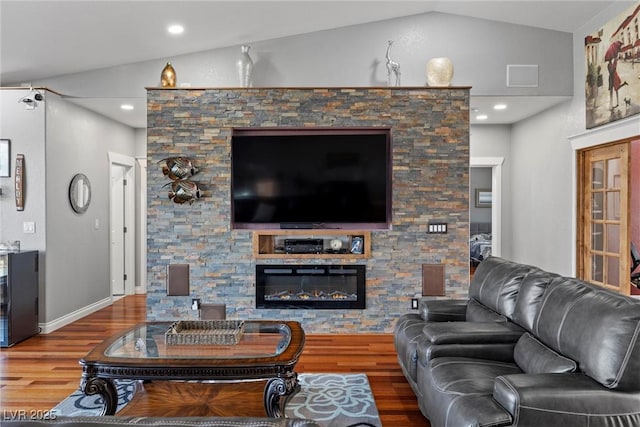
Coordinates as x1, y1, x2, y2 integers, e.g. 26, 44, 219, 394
108, 152, 136, 298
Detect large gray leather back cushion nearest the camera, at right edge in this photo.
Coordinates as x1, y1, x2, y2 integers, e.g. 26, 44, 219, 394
533, 279, 640, 391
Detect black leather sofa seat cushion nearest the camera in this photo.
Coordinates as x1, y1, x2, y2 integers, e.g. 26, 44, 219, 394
418, 357, 522, 427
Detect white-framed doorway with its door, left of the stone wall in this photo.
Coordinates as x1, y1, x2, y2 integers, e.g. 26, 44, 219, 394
109, 153, 135, 297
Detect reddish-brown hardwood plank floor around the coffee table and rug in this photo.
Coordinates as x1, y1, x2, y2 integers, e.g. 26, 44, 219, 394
0, 295, 429, 427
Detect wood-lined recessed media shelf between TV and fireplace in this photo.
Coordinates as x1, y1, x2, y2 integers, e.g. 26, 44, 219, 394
253, 230, 371, 259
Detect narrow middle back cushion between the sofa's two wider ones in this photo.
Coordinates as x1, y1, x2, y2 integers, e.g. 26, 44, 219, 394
512, 269, 562, 331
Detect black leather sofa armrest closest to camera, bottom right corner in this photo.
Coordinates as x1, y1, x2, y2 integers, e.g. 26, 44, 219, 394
493, 373, 640, 427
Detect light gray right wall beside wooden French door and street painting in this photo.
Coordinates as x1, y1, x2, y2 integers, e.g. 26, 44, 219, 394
504, 3, 640, 275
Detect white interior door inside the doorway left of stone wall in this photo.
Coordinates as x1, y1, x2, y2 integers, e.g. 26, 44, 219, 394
110, 164, 126, 295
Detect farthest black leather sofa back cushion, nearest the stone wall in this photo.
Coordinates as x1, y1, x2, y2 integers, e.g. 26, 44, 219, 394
467, 257, 535, 320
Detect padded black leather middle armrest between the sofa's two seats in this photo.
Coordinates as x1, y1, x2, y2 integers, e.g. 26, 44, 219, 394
422, 322, 525, 344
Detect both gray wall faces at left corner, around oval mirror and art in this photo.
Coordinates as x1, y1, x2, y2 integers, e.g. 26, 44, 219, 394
0, 89, 135, 330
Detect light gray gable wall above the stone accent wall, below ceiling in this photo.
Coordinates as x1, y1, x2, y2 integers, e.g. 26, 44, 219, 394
27, 13, 573, 98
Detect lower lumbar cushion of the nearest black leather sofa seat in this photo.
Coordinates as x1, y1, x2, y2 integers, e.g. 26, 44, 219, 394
513, 332, 578, 374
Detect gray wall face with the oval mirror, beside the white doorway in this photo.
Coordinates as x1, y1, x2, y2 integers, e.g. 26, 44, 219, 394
43, 94, 135, 322
